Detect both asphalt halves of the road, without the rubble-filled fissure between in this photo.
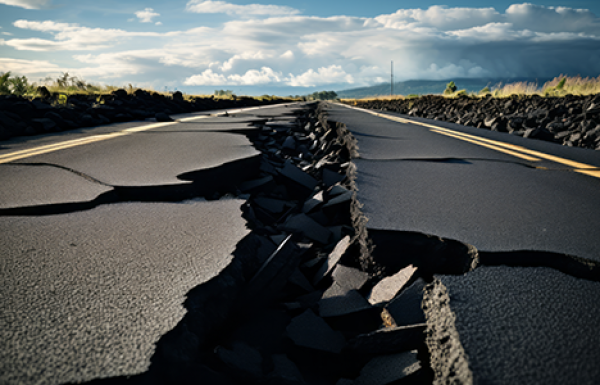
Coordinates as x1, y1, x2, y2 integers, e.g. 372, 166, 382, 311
0, 103, 600, 384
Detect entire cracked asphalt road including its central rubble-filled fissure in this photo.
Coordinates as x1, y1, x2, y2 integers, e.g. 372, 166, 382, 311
0, 103, 600, 385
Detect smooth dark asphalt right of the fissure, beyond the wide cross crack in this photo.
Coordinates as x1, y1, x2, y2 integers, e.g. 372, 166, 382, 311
328, 105, 600, 261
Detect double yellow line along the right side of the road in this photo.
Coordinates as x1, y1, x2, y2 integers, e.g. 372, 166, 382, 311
346, 106, 600, 178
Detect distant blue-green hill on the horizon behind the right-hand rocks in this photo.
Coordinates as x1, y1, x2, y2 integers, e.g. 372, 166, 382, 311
336, 78, 552, 99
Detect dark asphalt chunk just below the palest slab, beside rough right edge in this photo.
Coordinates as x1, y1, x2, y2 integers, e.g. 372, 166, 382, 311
382, 278, 427, 326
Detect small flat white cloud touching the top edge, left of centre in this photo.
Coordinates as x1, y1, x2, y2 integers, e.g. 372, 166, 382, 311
185, 0, 300, 16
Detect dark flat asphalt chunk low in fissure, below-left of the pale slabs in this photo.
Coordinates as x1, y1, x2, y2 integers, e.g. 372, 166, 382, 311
286, 309, 345, 354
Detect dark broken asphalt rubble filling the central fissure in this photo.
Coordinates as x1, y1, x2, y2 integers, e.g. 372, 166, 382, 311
136, 105, 432, 385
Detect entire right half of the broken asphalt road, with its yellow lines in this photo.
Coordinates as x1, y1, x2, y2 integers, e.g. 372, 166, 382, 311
328, 104, 600, 385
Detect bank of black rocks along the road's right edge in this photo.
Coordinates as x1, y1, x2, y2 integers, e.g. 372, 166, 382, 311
346, 95, 600, 150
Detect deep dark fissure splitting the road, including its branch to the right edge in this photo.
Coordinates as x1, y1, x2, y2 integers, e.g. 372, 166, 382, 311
44, 105, 600, 384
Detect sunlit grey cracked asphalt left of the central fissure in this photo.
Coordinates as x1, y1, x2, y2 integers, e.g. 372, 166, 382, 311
0, 102, 300, 384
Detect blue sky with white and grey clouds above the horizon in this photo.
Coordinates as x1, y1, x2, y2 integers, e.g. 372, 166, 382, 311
0, 0, 600, 95
